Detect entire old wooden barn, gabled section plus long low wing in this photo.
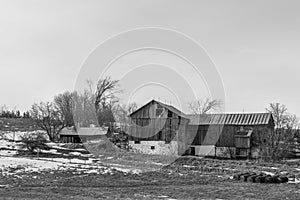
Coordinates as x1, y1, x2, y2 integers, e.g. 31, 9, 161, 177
126, 100, 274, 157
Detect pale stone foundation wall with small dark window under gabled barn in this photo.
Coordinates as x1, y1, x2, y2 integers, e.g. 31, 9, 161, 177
129, 141, 178, 156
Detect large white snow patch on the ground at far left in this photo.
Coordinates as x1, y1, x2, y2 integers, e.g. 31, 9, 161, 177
0, 132, 140, 175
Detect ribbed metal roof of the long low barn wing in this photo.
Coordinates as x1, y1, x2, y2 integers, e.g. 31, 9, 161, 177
187, 113, 273, 125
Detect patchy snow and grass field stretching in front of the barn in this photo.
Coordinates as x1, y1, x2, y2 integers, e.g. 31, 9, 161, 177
0, 132, 300, 199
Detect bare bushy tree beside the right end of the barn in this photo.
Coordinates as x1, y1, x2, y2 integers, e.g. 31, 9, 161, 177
265, 103, 299, 161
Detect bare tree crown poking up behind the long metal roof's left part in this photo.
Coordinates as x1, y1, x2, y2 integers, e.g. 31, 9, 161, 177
189, 98, 222, 114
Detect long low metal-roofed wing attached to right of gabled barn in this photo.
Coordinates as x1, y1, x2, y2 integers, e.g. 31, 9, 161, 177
187, 113, 274, 157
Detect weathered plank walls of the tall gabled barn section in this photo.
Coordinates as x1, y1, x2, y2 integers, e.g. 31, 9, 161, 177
128, 102, 189, 154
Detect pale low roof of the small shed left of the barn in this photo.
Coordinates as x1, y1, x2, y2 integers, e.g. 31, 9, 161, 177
60, 127, 107, 136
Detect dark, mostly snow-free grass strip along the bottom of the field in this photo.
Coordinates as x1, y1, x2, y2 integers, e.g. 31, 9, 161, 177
0, 165, 300, 199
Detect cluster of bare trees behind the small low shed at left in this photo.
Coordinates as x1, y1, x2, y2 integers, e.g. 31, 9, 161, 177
30, 76, 137, 141
